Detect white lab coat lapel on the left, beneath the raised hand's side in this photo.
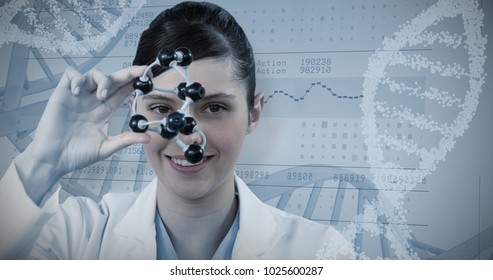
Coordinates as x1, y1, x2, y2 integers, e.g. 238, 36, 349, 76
101, 179, 156, 259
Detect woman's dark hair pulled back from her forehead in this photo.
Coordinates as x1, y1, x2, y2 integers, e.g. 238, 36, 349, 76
133, 2, 255, 109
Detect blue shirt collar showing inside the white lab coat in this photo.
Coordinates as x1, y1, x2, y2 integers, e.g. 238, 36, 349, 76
155, 210, 240, 260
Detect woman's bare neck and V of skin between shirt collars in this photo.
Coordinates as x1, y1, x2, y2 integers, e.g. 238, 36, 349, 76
157, 176, 238, 259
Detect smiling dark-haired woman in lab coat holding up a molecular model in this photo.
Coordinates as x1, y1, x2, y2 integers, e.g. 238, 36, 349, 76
0, 2, 354, 259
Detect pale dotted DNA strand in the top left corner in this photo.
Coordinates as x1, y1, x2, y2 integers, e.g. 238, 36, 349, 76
0, 0, 145, 55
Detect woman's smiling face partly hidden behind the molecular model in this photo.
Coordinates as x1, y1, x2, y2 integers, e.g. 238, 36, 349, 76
131, 58, 263, 199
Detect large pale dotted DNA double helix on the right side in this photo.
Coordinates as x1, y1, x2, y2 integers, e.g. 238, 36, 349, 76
314, 0, 486, 259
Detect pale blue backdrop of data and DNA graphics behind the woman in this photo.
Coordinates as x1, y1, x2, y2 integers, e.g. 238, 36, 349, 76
0, 0, 493, 259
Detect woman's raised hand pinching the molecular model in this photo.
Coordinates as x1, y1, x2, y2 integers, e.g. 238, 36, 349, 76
14, 66, 150, 201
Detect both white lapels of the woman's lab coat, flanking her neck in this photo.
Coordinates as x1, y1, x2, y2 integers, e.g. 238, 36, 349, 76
105, 177, 286, 259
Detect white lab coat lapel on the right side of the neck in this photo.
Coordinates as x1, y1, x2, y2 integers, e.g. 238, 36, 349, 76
232, 178, 285, 259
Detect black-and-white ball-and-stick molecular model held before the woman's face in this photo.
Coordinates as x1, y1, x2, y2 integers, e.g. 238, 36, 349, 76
129, 48, 206, 164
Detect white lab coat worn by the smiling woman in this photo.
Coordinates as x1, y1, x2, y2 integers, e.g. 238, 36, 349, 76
0, 164, 354, 259
